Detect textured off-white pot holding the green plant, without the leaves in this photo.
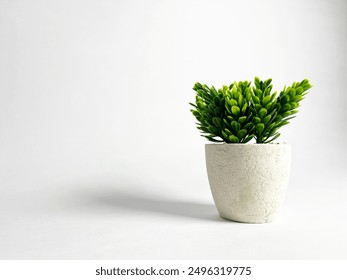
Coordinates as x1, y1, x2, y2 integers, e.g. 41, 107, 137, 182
205, 144, 291, 223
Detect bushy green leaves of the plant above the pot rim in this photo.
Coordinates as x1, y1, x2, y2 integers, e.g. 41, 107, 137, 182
190, 77, 312, 143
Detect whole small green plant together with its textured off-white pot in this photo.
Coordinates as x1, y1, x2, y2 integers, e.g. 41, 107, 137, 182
190, 77, 312, 223
